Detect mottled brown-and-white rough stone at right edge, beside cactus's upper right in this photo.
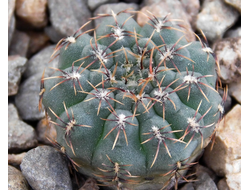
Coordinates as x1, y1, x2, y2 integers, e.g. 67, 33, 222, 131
214, 37, 241, 84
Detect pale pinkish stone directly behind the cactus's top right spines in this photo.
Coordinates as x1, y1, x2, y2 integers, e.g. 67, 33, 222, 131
137, 0, 196, 41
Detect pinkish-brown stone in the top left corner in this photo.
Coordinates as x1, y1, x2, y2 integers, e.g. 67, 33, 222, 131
16, 0, 48, 28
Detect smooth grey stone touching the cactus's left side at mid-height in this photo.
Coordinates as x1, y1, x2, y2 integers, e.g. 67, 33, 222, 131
15, 73, 45, 121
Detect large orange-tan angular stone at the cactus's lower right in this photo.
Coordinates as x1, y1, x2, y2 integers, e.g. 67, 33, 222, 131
203, 104, 241, 177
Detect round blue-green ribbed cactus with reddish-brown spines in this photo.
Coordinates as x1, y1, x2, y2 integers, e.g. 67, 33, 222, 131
39, 10, 223, 189
